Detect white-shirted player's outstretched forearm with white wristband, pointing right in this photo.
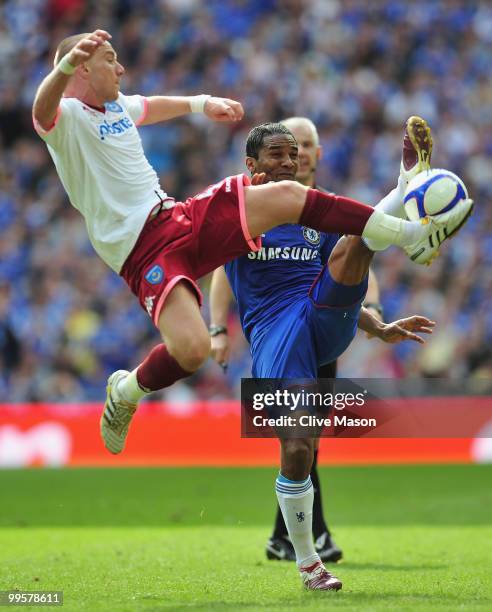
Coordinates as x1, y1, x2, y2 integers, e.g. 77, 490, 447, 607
140, 94, 244, 125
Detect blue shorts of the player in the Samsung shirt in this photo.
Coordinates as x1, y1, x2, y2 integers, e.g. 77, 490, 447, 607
251, 266, 367, 379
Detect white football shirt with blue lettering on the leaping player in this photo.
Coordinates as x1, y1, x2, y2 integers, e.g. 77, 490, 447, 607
35, 93, 173, 273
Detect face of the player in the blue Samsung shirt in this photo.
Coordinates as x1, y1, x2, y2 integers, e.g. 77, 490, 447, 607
252, 134, 299, 181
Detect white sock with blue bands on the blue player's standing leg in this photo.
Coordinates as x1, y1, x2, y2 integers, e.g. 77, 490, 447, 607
275, 474, 320, 567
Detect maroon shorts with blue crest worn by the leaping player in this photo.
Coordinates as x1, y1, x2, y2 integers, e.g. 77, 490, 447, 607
120, 174, 261, 326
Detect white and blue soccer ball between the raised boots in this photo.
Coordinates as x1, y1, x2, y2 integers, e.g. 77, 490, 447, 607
403, 168, 468, 221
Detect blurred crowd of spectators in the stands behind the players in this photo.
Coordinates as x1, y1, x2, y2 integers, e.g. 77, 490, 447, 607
0, 0, 492, 402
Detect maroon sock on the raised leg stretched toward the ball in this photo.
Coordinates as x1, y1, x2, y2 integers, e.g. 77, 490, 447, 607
299, 189, 374, 236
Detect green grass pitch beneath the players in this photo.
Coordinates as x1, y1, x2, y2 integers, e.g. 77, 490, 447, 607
0, 465, 492, 612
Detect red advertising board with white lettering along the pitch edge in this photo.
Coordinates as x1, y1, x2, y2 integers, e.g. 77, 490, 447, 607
0, 401, 492, 467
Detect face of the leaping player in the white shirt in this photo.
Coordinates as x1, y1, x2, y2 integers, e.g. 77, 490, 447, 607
86, 42, 125, 102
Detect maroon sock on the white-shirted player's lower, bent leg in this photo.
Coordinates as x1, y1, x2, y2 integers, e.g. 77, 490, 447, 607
137, 344, 193, 391
